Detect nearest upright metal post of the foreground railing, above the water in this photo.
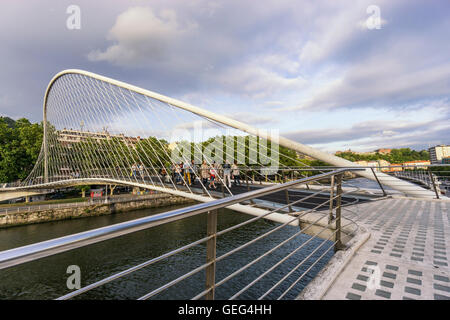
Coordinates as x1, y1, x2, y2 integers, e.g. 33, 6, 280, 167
205, 210, 217, 300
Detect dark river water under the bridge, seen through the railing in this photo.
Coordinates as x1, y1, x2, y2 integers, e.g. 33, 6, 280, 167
0, 206, 333, 299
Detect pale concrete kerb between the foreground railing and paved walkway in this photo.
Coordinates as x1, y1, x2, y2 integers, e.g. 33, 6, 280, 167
296, 227, 371, 300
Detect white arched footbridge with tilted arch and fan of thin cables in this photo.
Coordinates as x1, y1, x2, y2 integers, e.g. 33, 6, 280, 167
0, 70, 434, 213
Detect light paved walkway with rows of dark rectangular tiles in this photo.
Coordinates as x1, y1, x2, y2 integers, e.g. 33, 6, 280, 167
324, 198, 450, 300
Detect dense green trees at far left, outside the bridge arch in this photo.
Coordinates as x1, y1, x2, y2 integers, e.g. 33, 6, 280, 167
0, 117, 44, 182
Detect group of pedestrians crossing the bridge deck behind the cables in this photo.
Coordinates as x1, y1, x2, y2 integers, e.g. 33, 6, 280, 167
169, 160, 241, 189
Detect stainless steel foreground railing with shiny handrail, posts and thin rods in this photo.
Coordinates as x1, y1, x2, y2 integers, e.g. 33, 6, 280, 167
0, 169, 361, 299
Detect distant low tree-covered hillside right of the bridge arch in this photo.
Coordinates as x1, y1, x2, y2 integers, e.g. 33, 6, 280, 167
337, 148, 430, 163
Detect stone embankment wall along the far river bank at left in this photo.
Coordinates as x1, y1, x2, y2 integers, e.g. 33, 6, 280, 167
0, 193, 194, 229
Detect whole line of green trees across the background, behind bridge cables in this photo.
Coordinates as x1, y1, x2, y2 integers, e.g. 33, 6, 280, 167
0, 117, 436, 185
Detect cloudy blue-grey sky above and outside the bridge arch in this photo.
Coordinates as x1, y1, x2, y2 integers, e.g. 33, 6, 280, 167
0, 0, 450, 152
